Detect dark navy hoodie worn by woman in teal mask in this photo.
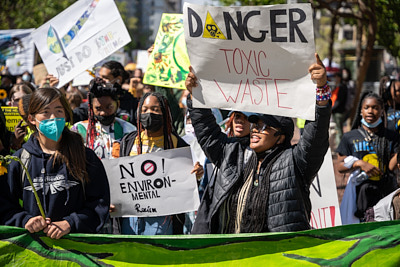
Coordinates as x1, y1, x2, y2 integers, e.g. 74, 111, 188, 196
0, 135, 110, 233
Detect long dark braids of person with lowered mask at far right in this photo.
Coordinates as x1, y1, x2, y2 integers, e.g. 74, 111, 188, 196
351, 91, 390, 177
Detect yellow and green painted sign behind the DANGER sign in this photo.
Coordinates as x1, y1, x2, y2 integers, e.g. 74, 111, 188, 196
143, 13, 190, 89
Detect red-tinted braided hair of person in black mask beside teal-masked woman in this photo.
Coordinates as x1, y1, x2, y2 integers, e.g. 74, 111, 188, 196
86, 77, 124, 149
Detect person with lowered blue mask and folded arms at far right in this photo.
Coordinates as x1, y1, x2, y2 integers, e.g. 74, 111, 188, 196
336, 92, 398, 224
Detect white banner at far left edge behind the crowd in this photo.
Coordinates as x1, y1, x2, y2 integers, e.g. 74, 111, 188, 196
0, 29, 35, 75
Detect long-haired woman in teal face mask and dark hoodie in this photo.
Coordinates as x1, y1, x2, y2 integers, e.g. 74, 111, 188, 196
0, 88, 110, 239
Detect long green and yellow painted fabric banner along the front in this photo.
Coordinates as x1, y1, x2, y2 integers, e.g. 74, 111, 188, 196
0, 221, 400, 266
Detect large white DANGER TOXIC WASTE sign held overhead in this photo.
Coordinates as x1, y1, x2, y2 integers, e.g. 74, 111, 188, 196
183, 3, 315, 120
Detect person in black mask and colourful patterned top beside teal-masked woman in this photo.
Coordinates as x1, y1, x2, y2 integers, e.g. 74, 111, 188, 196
72, 78, 136, 159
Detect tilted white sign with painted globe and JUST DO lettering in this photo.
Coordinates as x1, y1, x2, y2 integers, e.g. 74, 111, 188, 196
32, 0, 131, 87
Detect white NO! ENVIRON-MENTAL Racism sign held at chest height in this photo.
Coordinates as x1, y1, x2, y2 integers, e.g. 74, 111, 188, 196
102, 147, 200, 217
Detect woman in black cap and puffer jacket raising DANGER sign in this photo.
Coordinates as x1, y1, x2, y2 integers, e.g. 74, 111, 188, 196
186, 54, 331, 234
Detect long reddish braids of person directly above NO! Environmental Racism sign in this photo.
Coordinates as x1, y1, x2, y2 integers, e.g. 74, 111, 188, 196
137, 92, 174, 154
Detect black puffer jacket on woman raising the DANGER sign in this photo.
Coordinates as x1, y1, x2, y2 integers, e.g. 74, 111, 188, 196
188, 98, 331, 234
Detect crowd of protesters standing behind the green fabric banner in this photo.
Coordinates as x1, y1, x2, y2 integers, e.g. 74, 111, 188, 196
0, 49, 400, 239
